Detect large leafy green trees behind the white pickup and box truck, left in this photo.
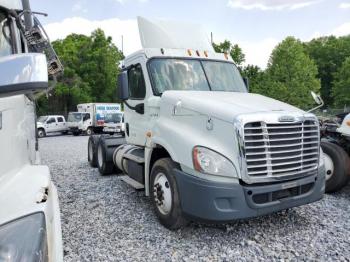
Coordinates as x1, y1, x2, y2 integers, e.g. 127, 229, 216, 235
38, 29, 124, 115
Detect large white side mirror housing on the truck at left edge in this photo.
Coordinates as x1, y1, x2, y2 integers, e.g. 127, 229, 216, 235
0, 53, 48, 97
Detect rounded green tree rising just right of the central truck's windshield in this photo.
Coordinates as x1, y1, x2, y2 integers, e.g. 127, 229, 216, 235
263, 37, 320, 109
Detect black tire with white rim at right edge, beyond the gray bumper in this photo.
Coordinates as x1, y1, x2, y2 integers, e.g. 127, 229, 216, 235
321, 141, 350, 193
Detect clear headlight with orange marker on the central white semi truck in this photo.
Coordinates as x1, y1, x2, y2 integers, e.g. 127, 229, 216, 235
193, 146, 236, 177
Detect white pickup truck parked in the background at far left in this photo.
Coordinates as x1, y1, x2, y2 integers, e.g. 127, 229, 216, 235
36, 115, 69, 137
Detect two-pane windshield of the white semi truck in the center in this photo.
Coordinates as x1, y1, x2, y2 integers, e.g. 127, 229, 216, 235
149, 58, 247, 95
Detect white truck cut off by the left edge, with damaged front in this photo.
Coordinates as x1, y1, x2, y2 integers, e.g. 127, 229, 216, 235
0, 0, 63, 261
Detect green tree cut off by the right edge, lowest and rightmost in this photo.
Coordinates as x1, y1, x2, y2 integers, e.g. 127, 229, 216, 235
332, 56, 350, 108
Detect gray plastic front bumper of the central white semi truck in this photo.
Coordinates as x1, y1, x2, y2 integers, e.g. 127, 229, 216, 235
174, 168, 325, 222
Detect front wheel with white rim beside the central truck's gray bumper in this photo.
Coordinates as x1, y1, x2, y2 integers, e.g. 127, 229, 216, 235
150, 158, 187, 229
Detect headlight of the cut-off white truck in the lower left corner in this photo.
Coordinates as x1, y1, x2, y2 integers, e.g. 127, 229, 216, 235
0, 213, 48, 262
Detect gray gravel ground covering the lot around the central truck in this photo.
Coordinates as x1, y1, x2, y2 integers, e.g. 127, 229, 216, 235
40, 136, 350, 261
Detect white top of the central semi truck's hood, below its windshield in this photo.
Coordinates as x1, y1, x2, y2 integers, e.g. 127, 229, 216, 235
162, 91, 304, 122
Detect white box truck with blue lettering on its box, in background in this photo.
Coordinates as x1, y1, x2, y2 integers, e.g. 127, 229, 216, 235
68, 103, 121, 135
